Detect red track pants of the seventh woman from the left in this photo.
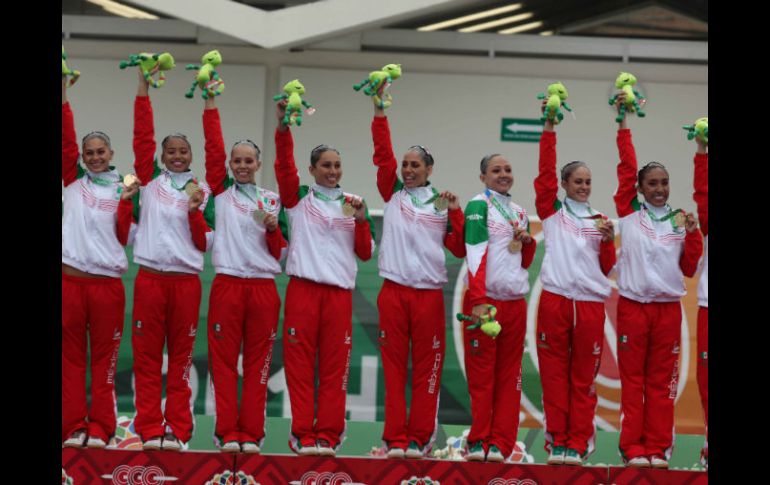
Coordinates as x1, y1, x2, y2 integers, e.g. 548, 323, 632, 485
537, 290, 605, 457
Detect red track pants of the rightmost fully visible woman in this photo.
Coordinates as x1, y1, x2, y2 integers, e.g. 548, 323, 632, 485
618, 296, 682, 460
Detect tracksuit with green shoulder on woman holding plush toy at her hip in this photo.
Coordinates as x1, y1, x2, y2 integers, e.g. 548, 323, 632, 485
463, 189, 537, 457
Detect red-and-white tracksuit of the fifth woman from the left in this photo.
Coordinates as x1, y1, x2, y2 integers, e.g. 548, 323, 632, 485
372, 117, 465, 453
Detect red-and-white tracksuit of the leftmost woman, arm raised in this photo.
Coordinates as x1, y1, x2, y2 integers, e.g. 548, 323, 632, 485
61, 103, 132, 443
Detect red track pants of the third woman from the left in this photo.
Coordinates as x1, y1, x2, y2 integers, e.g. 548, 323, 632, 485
207, 274, 281, 445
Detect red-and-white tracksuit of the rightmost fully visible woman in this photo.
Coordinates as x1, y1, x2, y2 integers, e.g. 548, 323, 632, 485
614, 129, 703, 461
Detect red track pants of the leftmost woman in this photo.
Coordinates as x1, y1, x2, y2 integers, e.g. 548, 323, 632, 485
61, 274, 126, 442
